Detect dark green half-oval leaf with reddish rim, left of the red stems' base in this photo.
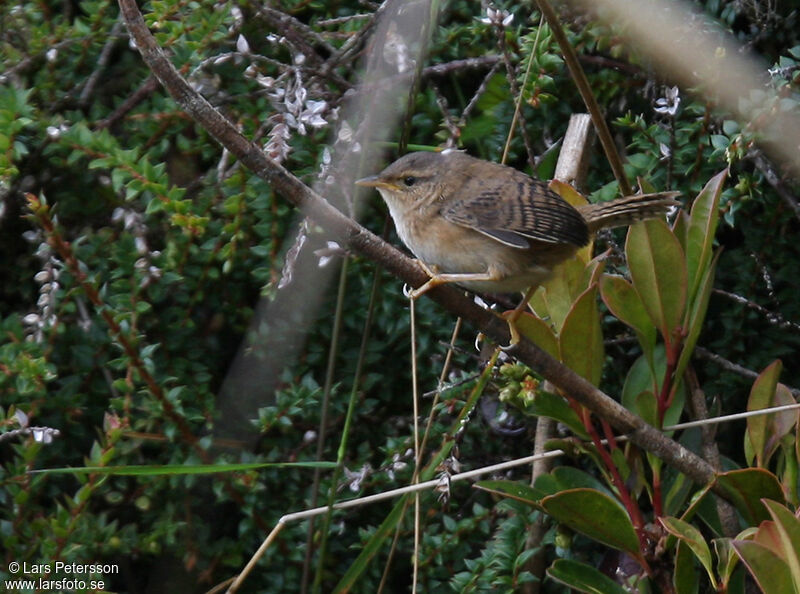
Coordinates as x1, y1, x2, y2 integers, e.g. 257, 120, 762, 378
541, 489, 641, 559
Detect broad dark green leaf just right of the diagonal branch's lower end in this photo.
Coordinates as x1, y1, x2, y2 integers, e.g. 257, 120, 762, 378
715, 468, 786, 526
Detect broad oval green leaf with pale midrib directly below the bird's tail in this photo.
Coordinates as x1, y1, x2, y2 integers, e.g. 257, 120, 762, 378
625, 219, 687, 340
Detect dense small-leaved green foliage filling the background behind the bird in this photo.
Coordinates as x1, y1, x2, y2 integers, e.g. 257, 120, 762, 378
0, 0, 800, 592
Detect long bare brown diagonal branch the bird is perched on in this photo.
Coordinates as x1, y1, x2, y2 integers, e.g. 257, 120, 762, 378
118, 0, 714, 484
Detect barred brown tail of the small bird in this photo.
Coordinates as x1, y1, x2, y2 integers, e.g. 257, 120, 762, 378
578, 192, 680, 233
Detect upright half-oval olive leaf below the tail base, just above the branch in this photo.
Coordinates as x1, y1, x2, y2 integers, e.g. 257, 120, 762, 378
558, 285, 605, 386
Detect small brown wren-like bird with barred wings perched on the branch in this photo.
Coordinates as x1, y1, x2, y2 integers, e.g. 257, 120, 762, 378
356, 150, 679, 297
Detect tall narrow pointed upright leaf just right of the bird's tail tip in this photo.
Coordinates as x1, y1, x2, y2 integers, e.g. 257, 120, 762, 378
686, 169, 727, 302
